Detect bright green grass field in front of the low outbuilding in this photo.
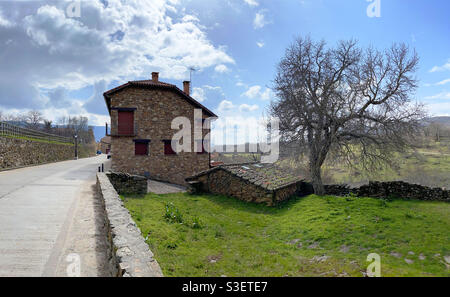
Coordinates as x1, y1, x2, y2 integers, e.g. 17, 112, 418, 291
123, 194, 450, 276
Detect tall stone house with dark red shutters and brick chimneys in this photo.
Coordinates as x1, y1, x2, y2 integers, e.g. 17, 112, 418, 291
103, 72, 217, 185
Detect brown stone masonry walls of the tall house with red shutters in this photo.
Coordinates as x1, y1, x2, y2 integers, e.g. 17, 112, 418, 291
111, 88, 209, 185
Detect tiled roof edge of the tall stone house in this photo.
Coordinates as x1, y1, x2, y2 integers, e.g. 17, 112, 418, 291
103, 80, 217, 117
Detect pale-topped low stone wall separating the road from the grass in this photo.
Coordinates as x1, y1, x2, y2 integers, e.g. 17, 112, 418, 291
97, 172, 163, 277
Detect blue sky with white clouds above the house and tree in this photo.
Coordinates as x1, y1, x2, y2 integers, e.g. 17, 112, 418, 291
0, 0, 450, 142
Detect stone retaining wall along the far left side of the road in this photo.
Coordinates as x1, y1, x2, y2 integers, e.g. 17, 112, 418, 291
0, 137, 75, 170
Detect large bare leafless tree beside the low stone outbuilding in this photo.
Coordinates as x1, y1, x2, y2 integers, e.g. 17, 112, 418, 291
270, 38, 424, 195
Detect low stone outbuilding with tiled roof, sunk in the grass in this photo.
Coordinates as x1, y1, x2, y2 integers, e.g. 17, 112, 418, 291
186, 163, 306, 206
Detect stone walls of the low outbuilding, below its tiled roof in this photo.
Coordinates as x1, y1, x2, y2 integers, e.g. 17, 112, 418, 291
197, 170, 299, 206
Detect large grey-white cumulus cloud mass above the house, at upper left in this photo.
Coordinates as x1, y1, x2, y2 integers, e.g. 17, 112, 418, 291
0, 0, 235, 121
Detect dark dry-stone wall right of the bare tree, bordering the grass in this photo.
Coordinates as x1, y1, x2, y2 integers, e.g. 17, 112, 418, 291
325, 181, 450, 202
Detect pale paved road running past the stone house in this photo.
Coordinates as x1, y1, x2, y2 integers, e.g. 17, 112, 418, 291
0, 156, 106, 276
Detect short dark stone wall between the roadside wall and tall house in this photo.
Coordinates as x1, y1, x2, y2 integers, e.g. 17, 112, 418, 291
106, 172, 147, 194
